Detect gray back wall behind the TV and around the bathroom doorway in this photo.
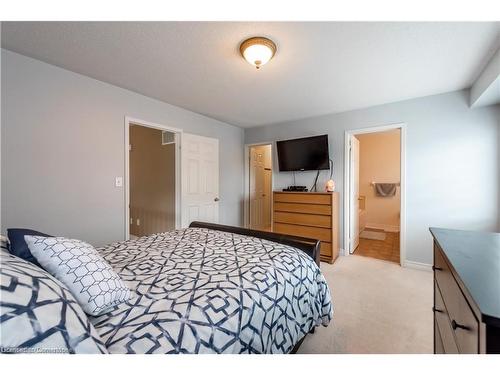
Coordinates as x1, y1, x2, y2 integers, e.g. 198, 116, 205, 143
245, 91, 500, 264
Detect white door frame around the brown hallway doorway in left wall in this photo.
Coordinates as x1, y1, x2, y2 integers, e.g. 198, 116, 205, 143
124, 116, 182, 240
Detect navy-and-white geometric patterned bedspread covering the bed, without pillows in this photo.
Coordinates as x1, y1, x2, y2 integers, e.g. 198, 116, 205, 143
91, 228, 332, 353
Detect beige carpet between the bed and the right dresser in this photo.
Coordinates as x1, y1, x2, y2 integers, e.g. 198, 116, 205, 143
299, 255, 433, 354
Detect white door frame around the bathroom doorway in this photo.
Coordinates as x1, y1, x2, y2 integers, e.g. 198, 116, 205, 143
343, 123, 406, 267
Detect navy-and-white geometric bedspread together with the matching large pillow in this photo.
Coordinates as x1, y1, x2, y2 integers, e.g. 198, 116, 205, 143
0, 228, 332, 353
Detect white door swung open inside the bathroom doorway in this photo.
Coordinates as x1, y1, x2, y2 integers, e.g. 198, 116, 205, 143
349, 136, 359, 254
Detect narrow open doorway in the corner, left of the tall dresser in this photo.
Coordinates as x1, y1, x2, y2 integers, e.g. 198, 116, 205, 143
247, 144, 273, 231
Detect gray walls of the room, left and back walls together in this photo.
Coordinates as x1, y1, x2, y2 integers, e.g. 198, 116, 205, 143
1, 50, 500, 263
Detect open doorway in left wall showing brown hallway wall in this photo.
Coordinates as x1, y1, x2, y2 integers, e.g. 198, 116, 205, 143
125, 119, 180, 239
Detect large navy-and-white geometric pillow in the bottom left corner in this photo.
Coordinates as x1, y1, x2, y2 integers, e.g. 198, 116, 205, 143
0, 249, 107, 353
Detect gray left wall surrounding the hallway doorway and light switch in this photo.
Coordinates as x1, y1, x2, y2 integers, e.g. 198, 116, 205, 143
1, 50, 244, 245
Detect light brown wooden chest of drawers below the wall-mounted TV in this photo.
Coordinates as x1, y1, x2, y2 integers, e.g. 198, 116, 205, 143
273, 191, 339, 263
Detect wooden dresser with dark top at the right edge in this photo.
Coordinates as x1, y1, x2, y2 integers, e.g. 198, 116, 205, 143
430, 228, 500, 354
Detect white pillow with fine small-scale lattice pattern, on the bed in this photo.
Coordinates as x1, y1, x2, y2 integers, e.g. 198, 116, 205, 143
24, 236, 130, 316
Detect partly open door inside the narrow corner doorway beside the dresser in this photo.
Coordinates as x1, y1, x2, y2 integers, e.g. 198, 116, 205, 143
250, 146, 266, 230
